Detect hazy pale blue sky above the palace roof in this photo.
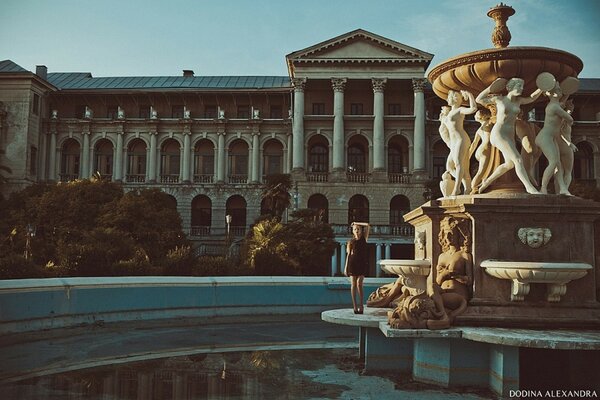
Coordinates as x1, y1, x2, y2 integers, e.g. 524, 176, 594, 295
0, 0, 600, 78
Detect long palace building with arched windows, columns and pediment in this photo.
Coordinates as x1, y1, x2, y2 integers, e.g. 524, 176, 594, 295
0, 29, 600, 274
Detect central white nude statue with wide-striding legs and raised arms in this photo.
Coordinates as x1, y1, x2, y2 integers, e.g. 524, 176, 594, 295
477, 78, 542, 194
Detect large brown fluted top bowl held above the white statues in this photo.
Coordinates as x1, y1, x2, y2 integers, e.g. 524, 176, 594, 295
427, 46, 583, 99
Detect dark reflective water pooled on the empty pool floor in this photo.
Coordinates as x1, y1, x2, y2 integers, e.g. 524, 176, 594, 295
0, 349, 490, 400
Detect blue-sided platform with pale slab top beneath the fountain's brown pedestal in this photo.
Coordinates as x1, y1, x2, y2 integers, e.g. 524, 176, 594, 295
321, 308, 600, 396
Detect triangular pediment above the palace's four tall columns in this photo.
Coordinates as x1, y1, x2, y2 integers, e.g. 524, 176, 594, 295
286, 29, 433, 63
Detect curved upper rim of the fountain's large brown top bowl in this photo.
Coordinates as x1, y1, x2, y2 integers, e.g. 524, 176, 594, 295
427, 46, 583, 84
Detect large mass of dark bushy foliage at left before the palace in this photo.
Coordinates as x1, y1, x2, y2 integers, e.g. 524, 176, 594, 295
0, 179, 187, 277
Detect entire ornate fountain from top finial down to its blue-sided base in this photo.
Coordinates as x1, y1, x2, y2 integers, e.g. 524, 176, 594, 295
322, 3, 600, 397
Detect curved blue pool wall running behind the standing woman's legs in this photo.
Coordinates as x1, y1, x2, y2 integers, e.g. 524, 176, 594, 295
0, 276, 391, 335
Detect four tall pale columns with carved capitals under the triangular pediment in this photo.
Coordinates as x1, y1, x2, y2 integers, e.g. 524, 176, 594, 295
292, 78, 426, 172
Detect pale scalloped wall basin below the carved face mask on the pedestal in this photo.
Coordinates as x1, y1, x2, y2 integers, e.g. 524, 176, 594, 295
481, 260, 592, 303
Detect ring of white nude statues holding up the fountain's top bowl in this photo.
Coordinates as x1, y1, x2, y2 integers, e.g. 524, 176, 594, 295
439, 73, 579, 196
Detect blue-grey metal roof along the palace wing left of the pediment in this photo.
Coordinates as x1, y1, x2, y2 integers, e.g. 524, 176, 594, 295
48, 72, 291, 90
